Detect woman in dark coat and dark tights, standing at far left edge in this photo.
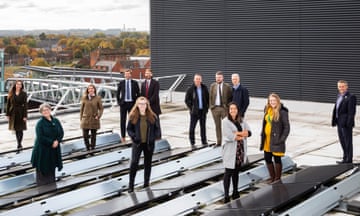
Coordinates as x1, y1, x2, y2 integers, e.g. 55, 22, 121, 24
6, 80, 28, 153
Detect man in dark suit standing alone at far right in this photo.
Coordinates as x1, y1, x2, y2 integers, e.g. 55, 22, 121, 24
331, 80, 356, 163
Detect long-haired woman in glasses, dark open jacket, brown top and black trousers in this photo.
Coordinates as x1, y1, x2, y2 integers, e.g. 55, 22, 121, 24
127, 97, 161, 192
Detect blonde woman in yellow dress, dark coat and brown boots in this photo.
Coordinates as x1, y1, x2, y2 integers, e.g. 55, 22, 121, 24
260, 93, 290, 183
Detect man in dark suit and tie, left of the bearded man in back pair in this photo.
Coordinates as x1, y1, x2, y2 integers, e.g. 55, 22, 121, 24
116, 69, 140, 143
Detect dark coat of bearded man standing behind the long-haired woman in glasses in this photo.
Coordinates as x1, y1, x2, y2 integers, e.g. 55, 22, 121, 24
141, 79, 161, 116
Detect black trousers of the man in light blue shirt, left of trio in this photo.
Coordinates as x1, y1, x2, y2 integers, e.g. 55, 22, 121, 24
189, 110, 207, 145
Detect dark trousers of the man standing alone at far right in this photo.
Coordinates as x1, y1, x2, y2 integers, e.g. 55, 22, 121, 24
337, 126, 353, 163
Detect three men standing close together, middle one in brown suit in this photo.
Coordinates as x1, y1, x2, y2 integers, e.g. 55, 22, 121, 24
185, 71, 249, 148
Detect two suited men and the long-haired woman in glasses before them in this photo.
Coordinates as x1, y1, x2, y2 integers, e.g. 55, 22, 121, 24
116, 68, 161, 192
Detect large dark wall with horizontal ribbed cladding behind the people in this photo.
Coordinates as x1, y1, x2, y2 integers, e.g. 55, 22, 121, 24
150, 0, 360, 102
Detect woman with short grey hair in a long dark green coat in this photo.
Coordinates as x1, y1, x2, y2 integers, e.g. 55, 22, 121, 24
31, 104, 64, 186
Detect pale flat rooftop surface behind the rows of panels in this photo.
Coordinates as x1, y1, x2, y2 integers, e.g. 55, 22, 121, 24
0, 92, 360, 166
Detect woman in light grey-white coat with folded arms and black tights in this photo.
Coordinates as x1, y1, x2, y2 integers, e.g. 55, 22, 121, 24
222, 102, 251, 203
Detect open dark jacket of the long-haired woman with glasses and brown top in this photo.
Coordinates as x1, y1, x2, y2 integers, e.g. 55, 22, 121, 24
127, 117, 161, 146
